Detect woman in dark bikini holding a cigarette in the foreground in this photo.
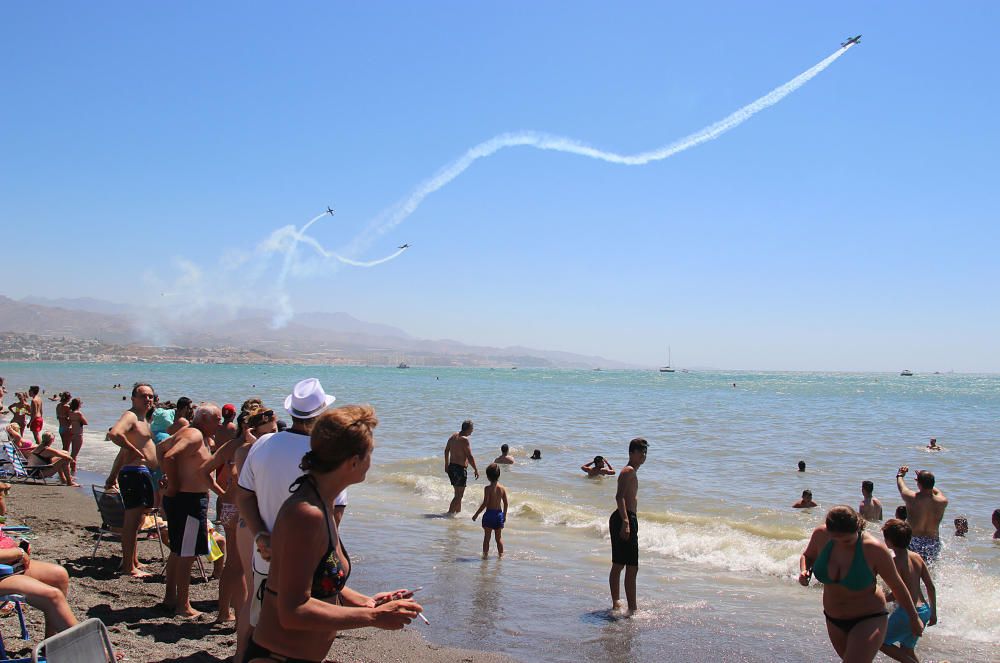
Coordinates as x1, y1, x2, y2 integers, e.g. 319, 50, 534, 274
250, 405, 426, 663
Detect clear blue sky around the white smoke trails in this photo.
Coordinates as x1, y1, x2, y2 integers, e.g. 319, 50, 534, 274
0, 2, 1000, 372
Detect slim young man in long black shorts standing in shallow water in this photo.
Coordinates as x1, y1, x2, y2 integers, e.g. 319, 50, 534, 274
608, 437, 649, 614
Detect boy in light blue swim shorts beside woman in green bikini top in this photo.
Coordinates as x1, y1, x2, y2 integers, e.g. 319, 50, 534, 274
880, 518, 937, 661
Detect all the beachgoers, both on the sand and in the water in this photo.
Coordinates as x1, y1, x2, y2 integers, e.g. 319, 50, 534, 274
0, 378, 1000, 663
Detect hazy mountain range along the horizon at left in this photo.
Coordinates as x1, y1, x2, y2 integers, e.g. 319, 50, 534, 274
0, 295, 635, 368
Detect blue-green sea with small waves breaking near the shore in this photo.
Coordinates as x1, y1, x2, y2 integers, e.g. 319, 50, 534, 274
0, 363, 1000, 661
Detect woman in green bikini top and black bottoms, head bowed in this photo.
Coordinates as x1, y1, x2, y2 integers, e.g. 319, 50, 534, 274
799, 506, 923, 663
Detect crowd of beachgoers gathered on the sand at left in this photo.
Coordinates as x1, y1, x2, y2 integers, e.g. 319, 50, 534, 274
0, 378, 422, 661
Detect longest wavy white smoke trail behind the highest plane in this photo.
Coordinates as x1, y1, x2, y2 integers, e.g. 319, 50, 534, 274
352, 44, 854, 250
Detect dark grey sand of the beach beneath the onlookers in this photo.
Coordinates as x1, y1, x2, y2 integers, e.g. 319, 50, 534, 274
0, 484, 513, 663
